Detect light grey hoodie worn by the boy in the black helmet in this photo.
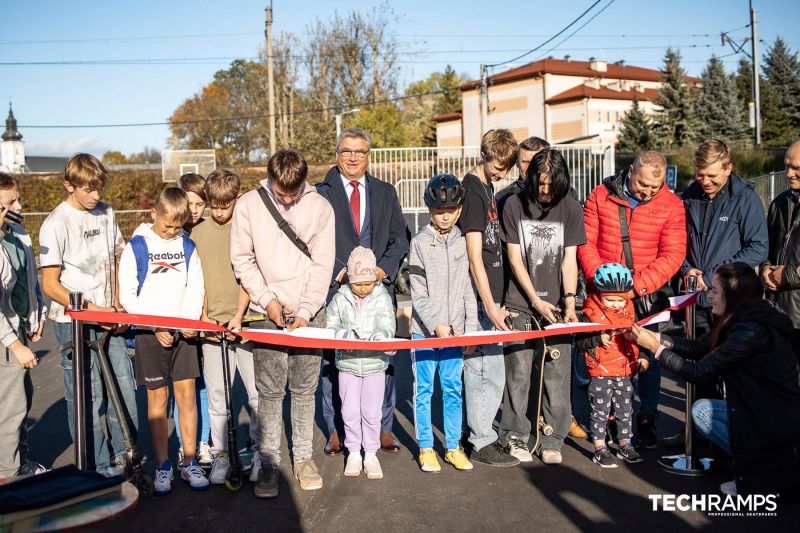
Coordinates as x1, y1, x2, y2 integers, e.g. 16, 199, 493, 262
408, 224, 478, 337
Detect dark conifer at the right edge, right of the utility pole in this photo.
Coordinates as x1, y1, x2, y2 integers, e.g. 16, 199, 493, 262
762, 37, 800, 146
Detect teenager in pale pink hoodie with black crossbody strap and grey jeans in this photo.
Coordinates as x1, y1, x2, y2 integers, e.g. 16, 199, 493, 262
231, 150, 336, 498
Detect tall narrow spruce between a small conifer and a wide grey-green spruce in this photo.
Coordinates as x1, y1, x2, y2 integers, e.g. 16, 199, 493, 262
655, 48, 697, 149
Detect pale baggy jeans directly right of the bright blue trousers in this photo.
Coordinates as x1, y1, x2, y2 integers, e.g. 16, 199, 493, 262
464, 303, 506, 450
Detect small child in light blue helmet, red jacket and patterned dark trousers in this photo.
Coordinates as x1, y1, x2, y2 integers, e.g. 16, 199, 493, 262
578, 263, 649, 468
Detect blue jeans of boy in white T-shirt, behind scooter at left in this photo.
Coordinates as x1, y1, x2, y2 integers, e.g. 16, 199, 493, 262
53, 322, 139, 471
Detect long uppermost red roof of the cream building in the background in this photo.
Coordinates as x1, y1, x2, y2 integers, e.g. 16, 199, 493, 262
459, 59, 698, 91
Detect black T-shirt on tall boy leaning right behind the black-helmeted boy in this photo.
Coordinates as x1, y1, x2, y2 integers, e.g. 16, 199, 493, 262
458, 174, 503, 303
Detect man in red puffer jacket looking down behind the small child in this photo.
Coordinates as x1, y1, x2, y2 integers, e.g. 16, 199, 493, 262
578, 151, 686, 449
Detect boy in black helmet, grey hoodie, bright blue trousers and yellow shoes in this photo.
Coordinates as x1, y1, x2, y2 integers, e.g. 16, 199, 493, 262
408, 174, 478, 473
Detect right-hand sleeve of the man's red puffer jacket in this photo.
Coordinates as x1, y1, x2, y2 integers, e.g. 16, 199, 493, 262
633, 196, 686, 295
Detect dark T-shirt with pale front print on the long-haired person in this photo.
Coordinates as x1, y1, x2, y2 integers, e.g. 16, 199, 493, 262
503, 195, 586, 309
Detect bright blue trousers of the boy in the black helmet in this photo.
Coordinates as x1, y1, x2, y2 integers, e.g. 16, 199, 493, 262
411, 333, 464, 450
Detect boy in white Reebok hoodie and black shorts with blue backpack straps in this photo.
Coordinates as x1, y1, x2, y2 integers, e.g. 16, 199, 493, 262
119, 187, 208, 494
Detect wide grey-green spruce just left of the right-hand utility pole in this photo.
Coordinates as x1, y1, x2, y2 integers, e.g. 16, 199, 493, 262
695, 55, 747, 143
